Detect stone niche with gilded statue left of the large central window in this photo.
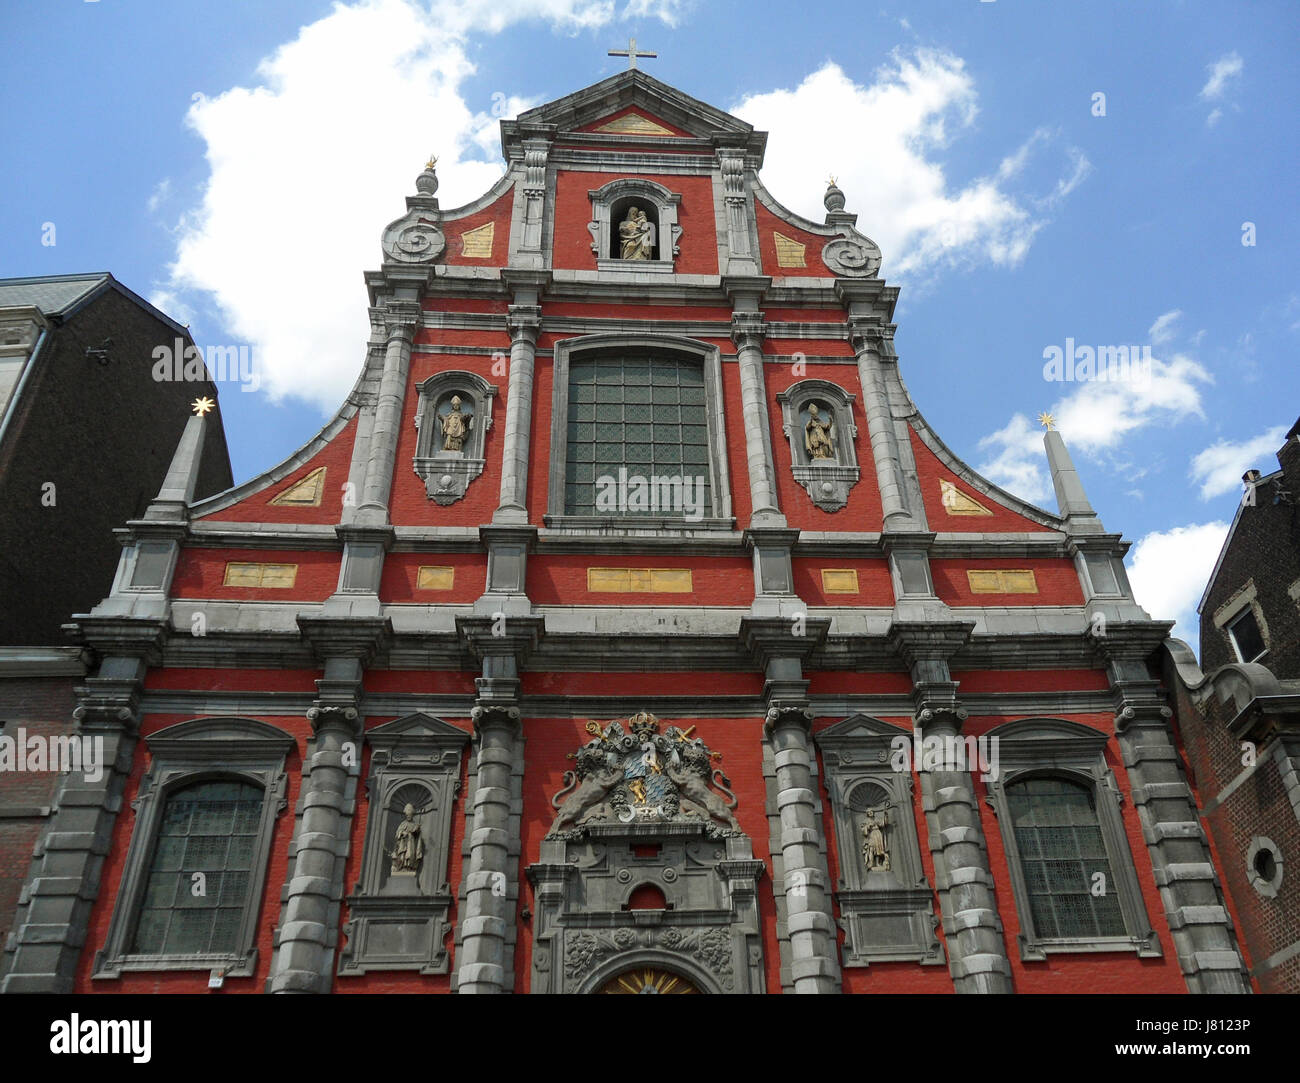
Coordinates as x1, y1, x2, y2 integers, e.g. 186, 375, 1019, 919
415, 369, 497, 504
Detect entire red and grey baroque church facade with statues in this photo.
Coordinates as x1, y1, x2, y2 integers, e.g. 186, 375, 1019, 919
0, 70, 1252, 993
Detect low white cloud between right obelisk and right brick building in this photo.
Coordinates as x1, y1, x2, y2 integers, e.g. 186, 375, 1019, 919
1127, 521, 1229, 649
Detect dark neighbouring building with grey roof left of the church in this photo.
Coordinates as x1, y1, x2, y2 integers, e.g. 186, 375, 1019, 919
0, 273, 231, 956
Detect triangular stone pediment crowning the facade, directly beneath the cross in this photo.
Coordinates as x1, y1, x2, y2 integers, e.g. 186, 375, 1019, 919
502, 69, 767, 159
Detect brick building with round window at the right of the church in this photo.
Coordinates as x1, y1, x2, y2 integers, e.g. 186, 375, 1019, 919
1164, 421, 1300, 993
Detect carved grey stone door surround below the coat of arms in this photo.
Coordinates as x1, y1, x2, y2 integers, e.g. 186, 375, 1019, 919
528, 820, 764, 993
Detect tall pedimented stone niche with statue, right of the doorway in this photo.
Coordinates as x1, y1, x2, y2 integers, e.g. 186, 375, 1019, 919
815, 715, 944, 966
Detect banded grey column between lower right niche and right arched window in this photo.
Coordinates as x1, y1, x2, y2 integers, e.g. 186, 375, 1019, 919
891, 623, 1013, 993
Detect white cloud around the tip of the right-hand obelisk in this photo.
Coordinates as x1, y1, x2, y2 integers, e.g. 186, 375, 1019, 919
978, 343, 1213, 503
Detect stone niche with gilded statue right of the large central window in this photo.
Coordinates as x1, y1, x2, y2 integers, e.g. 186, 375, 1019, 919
776, 380, 862, 511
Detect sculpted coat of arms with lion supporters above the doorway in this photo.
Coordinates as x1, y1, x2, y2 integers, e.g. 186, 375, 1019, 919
547, 711, 740, 839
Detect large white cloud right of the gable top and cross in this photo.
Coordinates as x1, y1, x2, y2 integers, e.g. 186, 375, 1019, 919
732, 48, 1091, 280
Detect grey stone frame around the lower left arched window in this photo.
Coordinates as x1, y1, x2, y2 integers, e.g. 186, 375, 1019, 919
91, 718, 298, 979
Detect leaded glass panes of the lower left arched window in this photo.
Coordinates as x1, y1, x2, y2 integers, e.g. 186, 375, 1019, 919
131, 780, 263, 956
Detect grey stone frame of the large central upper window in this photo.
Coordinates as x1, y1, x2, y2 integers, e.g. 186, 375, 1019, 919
543, 333, 735, 530
